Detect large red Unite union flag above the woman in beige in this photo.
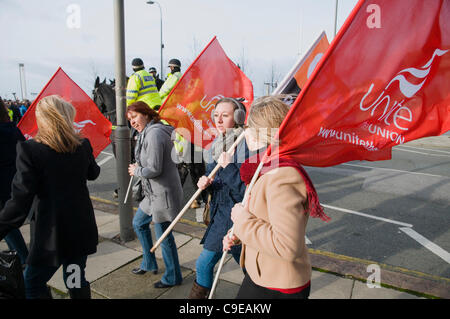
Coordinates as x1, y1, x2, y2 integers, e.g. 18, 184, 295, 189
272, 0, 450, 166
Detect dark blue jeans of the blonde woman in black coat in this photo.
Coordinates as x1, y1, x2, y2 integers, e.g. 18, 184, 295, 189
23, 256, 89, 299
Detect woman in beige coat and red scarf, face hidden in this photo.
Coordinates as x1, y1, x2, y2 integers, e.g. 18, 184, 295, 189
223, 97, 328, 299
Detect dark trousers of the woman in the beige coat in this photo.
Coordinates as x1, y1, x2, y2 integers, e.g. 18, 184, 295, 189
236, 274, 311, 299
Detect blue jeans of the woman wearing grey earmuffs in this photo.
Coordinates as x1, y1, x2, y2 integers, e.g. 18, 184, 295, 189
195, 248, 240, 289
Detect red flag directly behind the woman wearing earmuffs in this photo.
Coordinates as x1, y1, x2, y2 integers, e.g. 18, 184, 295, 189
159, 37, 253, 148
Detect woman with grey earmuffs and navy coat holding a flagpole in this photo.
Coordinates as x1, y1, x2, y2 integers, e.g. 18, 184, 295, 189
189, 98, 248, 299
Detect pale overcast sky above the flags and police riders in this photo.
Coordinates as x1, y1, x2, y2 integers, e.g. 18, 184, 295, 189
0, 0, 357, 99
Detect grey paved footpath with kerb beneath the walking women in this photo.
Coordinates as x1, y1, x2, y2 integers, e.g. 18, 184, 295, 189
0, 202, 444, 299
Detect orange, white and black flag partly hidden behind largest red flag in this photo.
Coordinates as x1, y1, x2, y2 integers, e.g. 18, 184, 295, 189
273, 32, 330, 94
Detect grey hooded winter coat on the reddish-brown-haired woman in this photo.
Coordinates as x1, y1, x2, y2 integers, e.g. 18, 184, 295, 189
134, 121, 183, 223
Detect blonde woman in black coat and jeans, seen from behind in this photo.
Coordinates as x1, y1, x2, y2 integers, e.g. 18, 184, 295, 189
0, 95, 100, 299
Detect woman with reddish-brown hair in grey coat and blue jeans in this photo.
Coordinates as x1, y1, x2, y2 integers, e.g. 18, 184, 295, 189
127, 101, 183, 288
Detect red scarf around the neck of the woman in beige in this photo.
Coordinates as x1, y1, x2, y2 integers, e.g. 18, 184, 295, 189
240, 153, 331, 222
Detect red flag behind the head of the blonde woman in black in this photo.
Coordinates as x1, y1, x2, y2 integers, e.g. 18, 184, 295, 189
18, 68, 112, 157
